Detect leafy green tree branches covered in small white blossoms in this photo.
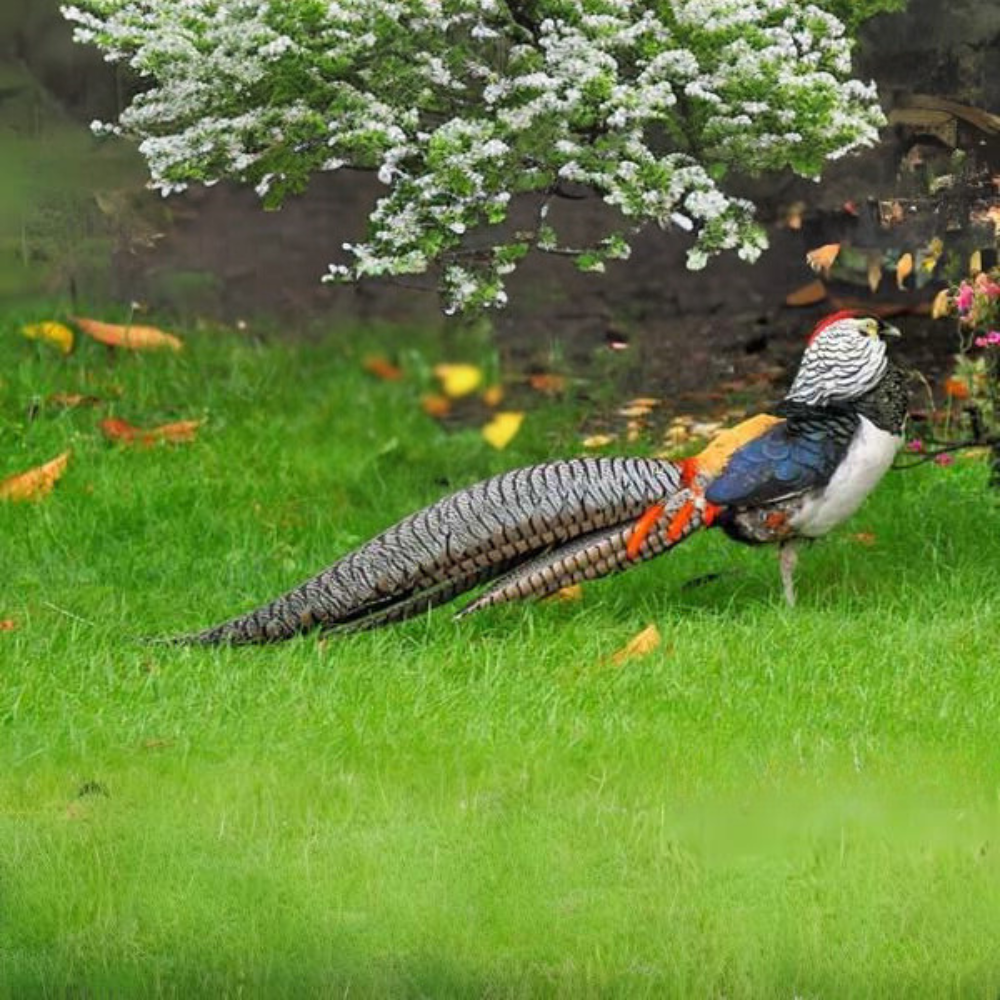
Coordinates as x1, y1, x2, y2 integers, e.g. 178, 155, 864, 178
64, 0, 901, 311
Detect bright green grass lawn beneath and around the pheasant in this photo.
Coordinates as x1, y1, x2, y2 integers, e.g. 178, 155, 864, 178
0, 313, 1000, 1000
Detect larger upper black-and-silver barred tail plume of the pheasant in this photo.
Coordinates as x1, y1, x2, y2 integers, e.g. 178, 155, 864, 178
170, 458, 681, 645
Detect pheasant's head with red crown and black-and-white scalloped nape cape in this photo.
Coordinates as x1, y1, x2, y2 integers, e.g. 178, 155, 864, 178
785, 310, 899, 406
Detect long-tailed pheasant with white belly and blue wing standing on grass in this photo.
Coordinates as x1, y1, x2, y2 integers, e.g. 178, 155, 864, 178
170, 311, 907, 645
